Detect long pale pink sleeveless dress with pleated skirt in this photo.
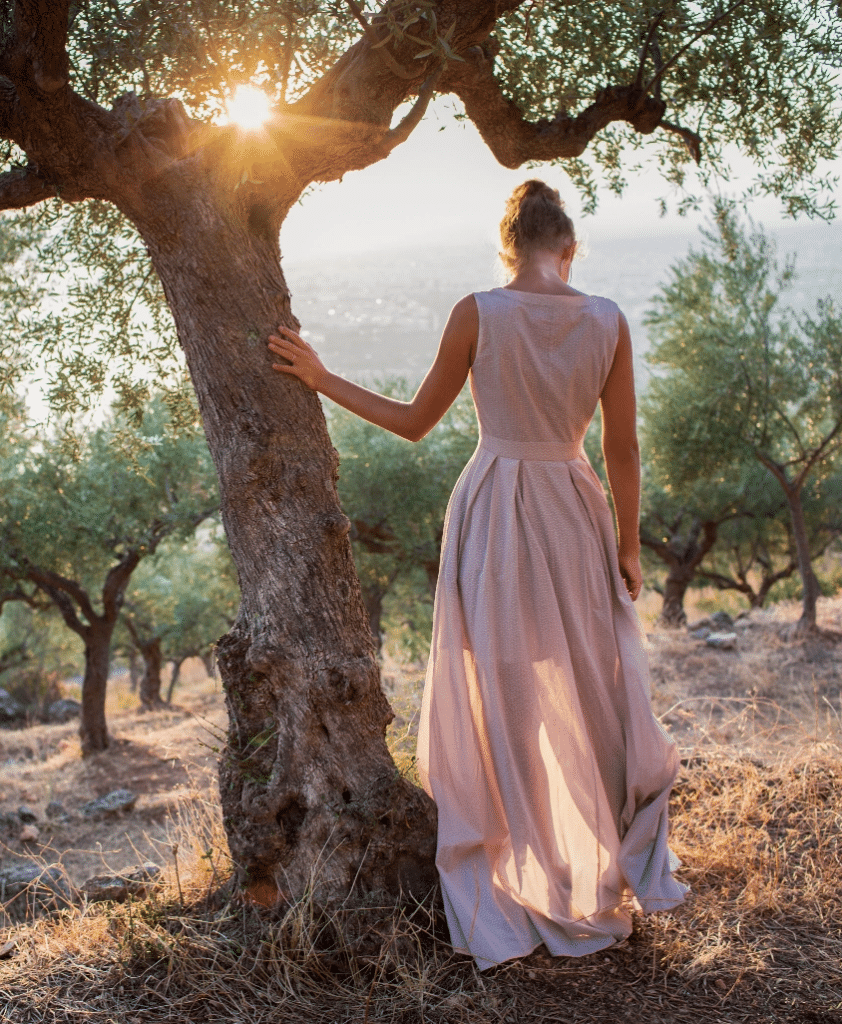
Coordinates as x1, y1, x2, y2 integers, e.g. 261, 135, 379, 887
418, 288, 686, 969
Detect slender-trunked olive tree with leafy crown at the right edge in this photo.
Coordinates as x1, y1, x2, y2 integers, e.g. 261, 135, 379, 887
644, 206, 842, 630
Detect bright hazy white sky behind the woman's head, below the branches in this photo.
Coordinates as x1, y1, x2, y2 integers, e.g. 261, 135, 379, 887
281, 97, 835, 258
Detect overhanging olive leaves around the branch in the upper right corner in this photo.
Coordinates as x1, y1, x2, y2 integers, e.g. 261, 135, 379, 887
495, 0, 842, 216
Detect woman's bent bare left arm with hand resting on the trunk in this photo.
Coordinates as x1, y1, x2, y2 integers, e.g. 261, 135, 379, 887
268, 295, 479, 441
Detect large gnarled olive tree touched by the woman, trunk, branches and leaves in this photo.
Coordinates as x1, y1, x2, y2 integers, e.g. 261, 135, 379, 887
0, 0, 842, 894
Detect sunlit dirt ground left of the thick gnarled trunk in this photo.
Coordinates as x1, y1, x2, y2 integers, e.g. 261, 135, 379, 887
0, 662, 226, 886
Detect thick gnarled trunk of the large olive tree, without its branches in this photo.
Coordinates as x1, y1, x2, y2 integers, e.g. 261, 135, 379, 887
127, 182, 435, 898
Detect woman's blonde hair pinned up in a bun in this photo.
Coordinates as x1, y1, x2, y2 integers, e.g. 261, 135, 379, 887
500, 178, 576, 273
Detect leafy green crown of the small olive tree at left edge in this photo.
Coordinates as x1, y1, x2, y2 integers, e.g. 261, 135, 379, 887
0, 389, 218, 594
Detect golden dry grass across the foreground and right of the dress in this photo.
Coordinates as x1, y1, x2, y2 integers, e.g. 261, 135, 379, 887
0, 602, 842, 1024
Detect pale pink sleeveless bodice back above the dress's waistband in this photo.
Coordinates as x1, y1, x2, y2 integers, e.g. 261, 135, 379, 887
471, 288, 620, 443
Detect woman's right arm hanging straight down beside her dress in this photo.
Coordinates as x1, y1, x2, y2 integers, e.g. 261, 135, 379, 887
599, 313, 643, 600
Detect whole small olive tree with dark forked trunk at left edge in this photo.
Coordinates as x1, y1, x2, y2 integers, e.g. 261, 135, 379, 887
0, 403, 218, 753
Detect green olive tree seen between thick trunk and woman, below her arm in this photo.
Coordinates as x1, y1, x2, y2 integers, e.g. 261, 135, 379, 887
329, 379, 478, 650
